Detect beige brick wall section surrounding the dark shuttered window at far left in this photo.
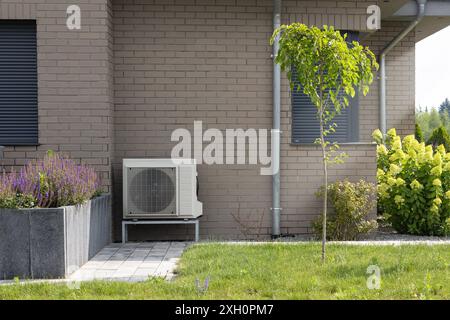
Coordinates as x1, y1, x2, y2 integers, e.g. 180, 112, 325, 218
0, 0, 113, 191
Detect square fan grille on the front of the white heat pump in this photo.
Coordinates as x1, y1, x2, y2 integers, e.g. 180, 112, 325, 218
128, 168, 176, 214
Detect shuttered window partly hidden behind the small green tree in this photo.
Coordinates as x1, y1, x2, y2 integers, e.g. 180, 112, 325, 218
291, 32, 359, 144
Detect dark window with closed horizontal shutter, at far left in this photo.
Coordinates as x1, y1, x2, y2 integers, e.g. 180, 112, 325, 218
0, 20, 38, 146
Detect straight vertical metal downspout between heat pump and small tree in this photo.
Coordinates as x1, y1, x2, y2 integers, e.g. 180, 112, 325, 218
272, 0, 281, 238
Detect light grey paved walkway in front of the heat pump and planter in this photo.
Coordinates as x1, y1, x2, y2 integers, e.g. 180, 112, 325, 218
68, 242, 190, 282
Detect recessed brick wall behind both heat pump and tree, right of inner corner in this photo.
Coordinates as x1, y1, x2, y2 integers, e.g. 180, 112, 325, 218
113, 0, 413, 238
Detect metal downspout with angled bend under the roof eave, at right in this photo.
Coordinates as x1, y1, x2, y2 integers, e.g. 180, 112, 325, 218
380, 0, 427, 136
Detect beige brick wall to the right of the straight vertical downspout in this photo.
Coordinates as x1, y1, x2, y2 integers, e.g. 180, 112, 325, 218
281, 1, 415, 233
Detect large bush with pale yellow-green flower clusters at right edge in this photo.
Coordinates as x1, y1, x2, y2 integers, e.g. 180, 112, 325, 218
373, 129, 450, 236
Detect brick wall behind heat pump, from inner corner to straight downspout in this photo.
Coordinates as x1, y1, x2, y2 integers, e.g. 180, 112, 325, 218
113, 0, 272, 238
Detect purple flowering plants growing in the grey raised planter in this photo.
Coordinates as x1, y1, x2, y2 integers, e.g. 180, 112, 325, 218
0, 152, 100, 208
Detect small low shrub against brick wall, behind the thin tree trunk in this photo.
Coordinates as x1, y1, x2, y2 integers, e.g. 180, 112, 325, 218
313, 180, 377, 240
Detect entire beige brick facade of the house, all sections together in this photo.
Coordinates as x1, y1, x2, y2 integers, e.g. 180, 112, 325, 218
0, 0, 414, 239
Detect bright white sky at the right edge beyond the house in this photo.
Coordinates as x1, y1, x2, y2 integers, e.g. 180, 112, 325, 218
416, 27, 450, 109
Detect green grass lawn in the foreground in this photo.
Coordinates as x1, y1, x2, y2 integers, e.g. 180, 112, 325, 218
0, 243, 450, 299
